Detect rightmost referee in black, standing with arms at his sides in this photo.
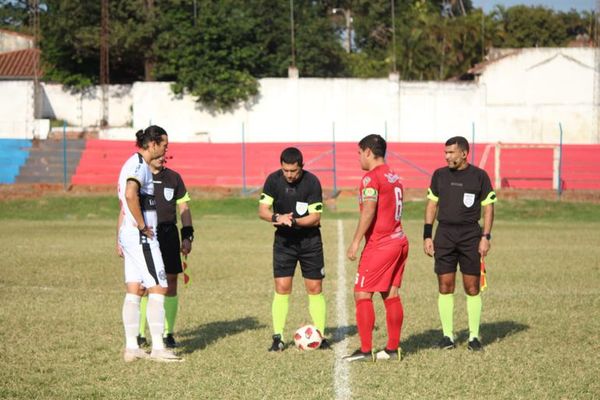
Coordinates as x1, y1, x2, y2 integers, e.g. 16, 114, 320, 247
423, 136, 497, 351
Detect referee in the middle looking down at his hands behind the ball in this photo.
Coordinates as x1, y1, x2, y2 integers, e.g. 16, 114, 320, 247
258, 147, 330, 351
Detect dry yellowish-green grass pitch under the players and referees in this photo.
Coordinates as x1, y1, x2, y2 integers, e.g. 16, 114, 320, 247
0, 196, 600, 399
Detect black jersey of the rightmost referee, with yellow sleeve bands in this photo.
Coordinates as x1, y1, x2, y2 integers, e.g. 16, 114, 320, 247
427, 164, 497, 225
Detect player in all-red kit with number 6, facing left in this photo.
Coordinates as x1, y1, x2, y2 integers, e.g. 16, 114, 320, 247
345, 135, 408, 361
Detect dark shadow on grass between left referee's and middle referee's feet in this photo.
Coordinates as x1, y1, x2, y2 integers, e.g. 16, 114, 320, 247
177, 317, 266, 354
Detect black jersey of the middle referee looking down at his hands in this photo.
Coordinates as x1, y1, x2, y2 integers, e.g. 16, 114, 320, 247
259, 170, 323, 236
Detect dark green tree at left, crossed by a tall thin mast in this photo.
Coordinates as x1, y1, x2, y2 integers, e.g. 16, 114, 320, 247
41, 0, 162, 88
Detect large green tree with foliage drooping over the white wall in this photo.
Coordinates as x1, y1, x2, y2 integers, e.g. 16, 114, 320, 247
156, 0, 345, 110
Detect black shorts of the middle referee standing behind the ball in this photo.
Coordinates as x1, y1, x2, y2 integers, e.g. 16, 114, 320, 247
273, 230, 325, 279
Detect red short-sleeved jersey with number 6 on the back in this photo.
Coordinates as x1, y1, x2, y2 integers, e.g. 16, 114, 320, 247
359, 164, 406, 247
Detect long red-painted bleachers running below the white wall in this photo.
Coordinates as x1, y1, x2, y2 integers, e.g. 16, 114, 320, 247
64, 139, 600, 190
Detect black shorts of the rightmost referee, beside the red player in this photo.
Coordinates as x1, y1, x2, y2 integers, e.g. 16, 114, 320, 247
433, 224, 481, 275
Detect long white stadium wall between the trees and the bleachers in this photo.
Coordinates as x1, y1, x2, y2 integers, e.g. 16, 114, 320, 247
0, 48, 600, 144
